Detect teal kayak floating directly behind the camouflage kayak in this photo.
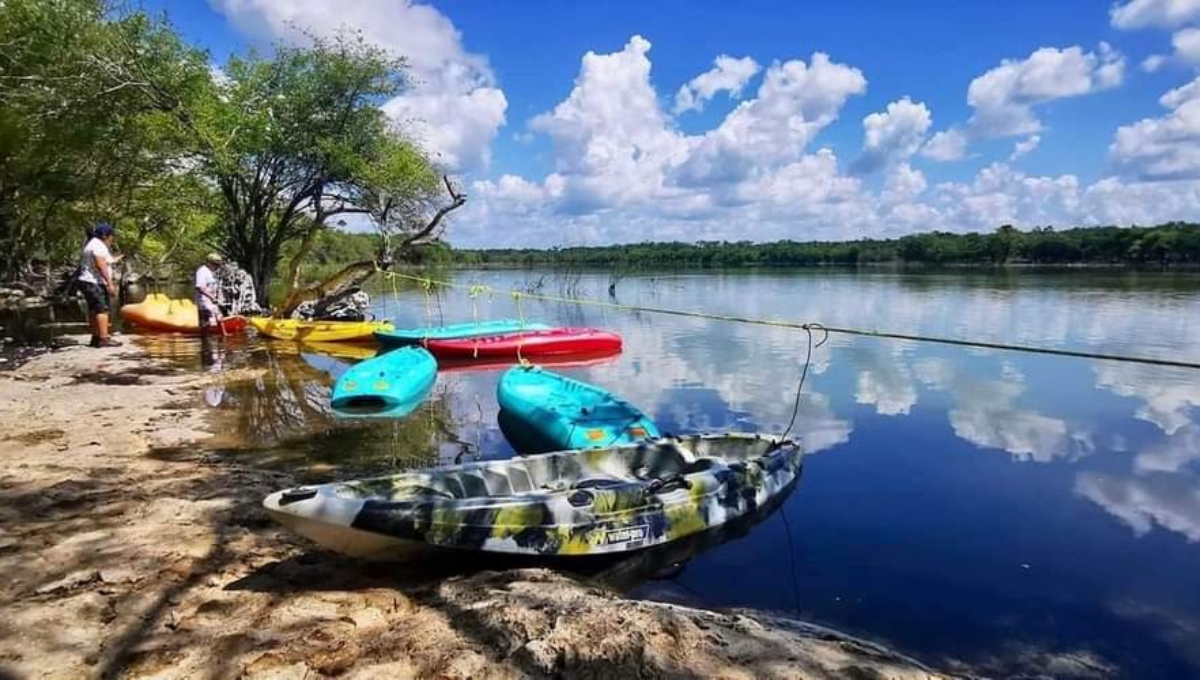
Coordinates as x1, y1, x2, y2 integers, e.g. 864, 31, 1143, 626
496, 366, 659, 453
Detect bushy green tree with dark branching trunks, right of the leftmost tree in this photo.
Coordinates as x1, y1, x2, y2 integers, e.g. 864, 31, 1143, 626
194, 34, 438, 302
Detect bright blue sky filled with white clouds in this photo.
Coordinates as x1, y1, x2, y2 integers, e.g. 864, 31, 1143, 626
145, 0, 1200, 247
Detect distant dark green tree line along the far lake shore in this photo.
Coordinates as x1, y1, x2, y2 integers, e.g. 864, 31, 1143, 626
452, 222, 1200, 269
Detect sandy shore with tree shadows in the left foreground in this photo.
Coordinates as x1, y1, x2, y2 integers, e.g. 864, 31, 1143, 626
0, 347, 942, 679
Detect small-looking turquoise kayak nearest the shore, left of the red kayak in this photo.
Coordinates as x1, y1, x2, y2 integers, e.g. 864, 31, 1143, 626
331, 347, 438, 416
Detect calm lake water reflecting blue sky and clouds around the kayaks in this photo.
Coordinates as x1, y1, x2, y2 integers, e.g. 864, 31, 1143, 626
136, 271, 1200, 678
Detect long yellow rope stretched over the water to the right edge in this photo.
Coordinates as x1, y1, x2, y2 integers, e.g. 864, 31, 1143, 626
380, 270, 1200, 369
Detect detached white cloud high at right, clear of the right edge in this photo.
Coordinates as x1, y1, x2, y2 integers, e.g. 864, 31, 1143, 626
967, 43, 1124, 137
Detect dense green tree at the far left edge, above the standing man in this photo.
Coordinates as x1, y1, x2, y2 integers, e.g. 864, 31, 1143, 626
0, 0, 208, 278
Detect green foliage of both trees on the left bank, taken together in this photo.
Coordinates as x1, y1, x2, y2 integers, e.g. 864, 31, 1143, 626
0, 0, 453, 301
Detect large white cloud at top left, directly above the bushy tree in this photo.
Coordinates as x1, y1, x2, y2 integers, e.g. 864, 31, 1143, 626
211, 0, 508, 170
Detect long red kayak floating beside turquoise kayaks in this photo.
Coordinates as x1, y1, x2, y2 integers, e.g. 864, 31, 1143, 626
425, 329, 620, 360
